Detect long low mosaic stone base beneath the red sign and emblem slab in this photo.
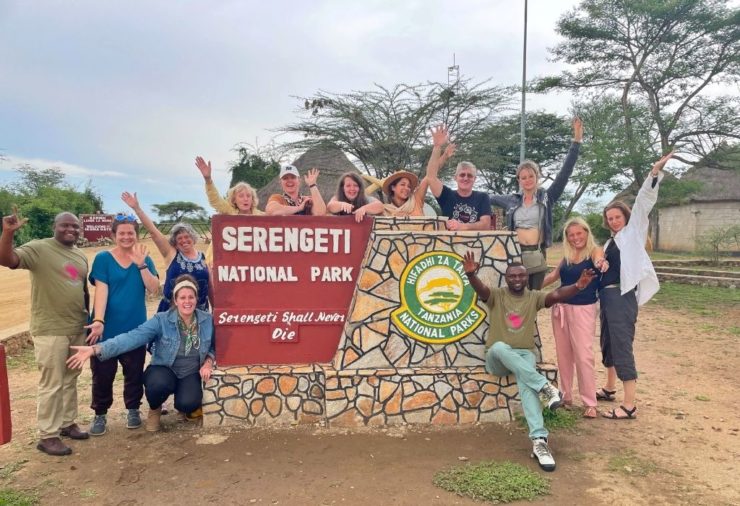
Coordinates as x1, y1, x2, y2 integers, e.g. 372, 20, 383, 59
203, 364, 557, 427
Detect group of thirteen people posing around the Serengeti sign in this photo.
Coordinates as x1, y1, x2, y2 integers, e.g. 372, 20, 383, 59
0, 118, 671, 471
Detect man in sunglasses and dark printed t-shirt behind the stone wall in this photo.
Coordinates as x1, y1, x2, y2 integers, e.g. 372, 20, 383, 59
427, 126, 491, 231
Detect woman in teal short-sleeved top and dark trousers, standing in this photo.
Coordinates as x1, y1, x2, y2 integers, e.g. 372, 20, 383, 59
87, 214, 159, 436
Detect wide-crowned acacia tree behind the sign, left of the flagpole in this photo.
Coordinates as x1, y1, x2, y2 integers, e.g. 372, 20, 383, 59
280, 80, 512, 178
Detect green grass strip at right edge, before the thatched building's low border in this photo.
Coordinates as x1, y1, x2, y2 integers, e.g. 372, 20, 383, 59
650, 282, 740, 316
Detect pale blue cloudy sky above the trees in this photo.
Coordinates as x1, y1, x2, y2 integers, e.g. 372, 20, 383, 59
0, 0, 577, 212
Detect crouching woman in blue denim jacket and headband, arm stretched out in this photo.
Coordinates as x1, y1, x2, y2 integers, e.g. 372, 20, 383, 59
67, 274, 215, 432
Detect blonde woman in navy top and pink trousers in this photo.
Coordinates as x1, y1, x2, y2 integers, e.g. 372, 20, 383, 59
543, 218, 609, 418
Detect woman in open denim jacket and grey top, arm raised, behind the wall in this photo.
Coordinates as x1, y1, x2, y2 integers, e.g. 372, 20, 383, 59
491, 117, 583, 290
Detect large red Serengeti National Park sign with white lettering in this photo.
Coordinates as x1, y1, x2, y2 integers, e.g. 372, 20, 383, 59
211, 215, 373, 365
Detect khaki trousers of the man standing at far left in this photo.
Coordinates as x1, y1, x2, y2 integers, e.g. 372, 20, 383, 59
32, 333, 85, 439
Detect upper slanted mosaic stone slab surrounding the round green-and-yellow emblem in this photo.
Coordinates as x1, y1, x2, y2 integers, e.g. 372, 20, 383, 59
334, 231, 542, 370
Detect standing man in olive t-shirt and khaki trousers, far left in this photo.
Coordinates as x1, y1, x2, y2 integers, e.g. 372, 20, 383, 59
0, 209, 88, 455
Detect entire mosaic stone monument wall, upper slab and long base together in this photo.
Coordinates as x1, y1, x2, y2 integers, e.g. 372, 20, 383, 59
203, 218, 557, 427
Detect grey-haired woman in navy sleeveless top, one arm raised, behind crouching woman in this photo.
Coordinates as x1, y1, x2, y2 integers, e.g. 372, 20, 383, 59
121, 192, 211, 312
